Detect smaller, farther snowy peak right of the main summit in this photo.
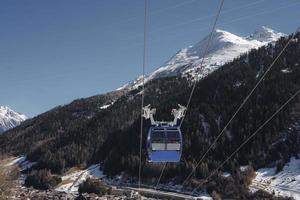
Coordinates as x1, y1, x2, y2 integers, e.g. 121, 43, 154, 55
247, 26, 285, 42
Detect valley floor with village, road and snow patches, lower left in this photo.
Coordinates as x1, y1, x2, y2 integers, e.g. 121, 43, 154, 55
1, 157, 207, 200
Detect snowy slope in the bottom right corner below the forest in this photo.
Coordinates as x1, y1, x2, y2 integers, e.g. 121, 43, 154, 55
250, 157, 300, 200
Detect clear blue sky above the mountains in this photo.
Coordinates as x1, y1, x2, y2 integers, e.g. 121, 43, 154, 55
0, 0, 300, 117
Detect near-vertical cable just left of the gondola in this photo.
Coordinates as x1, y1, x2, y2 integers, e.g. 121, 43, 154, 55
138, 0, 148, 188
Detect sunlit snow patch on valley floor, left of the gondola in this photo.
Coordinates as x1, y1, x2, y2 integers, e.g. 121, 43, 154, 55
56, 164, 104, 193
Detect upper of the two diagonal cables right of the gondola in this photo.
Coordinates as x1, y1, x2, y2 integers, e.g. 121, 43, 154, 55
181, 31, 297, 188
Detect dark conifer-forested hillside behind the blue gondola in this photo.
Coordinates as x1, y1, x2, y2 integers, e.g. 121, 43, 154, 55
0, 33, 300, 198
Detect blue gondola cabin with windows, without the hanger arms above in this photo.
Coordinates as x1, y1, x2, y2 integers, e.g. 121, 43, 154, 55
147, 125, 182, 162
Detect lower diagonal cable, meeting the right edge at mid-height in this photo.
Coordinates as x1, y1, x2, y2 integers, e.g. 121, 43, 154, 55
194, 89, 300, 192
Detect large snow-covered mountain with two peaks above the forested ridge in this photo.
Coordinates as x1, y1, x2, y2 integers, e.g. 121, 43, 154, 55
119, 26, 285, 89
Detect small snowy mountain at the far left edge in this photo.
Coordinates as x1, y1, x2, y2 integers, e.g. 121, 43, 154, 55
0, 106, 27, 134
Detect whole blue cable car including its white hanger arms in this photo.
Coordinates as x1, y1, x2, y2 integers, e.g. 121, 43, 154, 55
143, 105, 185, 163
